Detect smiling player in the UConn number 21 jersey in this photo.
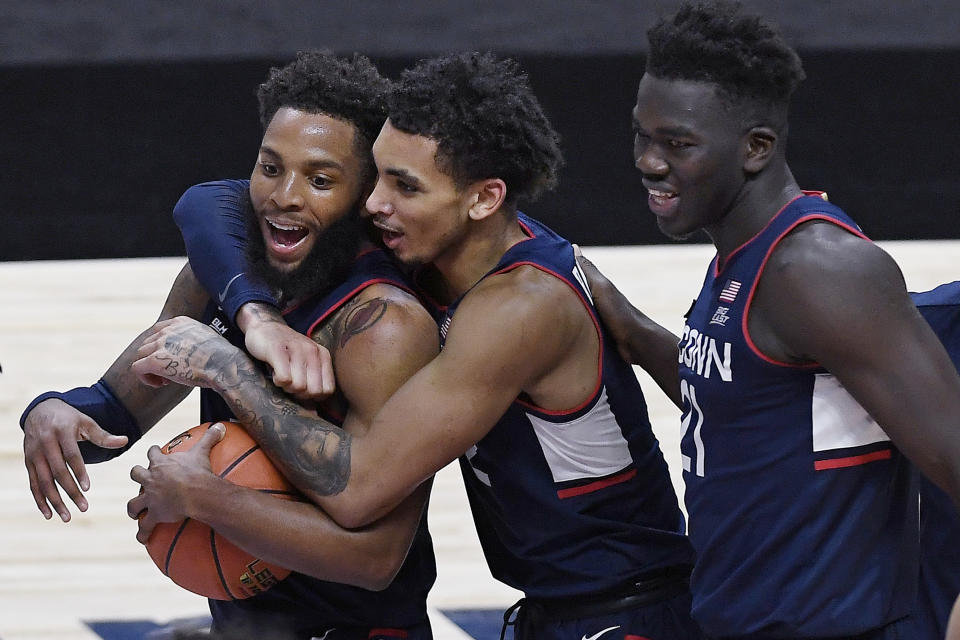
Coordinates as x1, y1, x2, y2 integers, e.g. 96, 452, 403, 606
572, 4, 960, 640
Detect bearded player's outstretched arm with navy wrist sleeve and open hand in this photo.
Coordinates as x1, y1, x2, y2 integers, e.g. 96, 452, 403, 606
21, 266, 207, 522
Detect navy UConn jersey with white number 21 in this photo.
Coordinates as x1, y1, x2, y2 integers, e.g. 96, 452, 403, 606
679, 195, 918, 638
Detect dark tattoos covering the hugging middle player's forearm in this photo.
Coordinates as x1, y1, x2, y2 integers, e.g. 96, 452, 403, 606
217, 351, 351, 496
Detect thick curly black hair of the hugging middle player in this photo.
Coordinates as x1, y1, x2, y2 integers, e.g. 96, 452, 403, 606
387, 52, 563, 208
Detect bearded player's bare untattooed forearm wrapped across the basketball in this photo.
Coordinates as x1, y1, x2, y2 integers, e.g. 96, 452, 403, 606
188, 475, 429, 590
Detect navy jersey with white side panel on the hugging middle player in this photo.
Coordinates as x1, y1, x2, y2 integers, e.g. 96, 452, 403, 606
439, 214, 693, 598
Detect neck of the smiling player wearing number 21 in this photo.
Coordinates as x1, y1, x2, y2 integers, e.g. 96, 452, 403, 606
705, 164, 803, 265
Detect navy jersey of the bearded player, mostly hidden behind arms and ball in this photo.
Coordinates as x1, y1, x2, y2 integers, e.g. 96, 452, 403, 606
200, 249, 436, 637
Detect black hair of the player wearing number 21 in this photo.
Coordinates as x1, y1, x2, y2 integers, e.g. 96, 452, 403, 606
646, 0, 806, 125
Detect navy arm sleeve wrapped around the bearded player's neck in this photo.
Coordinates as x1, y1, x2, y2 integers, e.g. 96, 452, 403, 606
173, 180, 278, 319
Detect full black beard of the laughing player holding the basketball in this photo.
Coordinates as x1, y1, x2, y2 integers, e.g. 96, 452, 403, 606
244, 197, 365, 307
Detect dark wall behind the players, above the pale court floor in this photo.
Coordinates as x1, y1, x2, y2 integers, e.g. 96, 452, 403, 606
0, 0, 960, 260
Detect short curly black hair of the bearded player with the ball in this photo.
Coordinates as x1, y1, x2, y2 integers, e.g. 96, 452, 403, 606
257, 50, 391, 178
